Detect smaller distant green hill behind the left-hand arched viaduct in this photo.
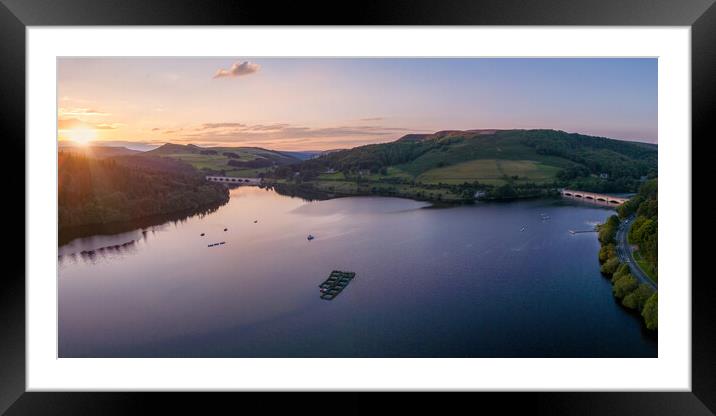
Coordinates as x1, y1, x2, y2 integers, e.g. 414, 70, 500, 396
144, 143, 301, 176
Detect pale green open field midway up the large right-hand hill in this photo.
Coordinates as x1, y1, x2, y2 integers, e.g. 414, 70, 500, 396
416, 159, 560, 185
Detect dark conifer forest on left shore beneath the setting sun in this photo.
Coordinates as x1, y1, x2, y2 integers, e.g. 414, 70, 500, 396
58, 152, 229, 230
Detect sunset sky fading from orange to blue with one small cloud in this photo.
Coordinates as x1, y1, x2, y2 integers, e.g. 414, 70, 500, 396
57, 57, 657, 150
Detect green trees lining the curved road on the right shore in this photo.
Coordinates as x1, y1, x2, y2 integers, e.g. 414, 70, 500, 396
599, 179, 658, 330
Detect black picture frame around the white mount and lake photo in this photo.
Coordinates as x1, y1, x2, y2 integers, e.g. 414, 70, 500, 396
0, 0, 716, 415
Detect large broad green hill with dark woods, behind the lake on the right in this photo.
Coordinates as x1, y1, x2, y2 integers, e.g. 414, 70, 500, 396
274, 130, 657, 199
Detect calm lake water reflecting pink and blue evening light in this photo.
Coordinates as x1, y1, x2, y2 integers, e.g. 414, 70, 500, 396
59, 187, 657, 357
